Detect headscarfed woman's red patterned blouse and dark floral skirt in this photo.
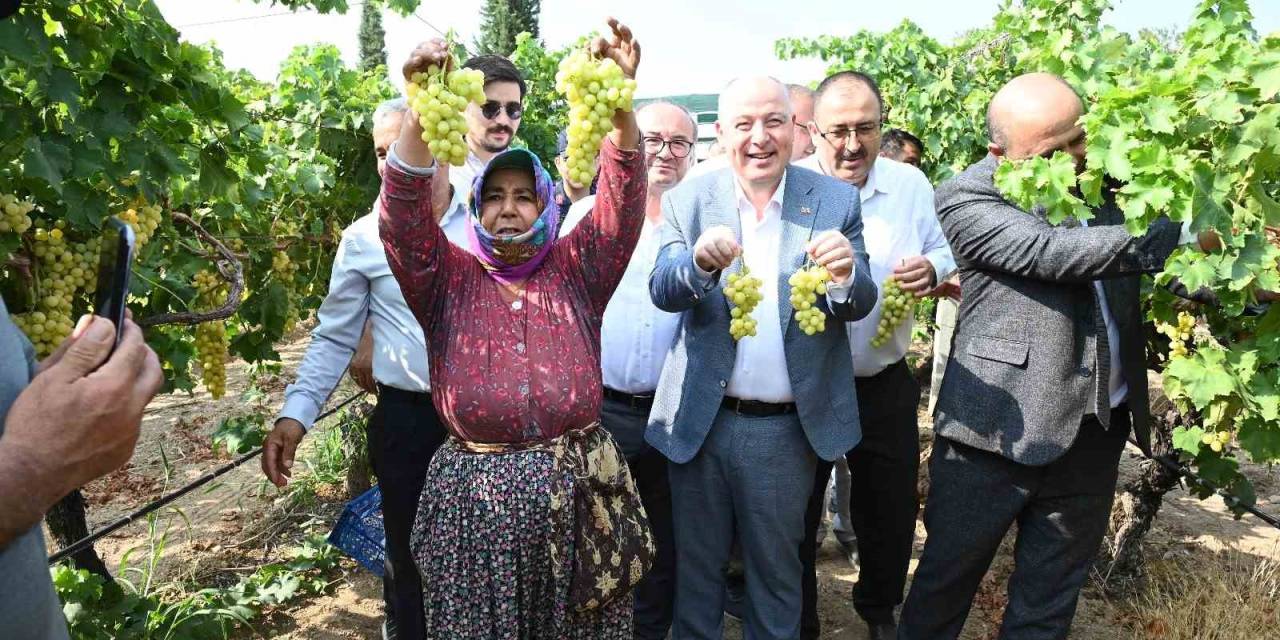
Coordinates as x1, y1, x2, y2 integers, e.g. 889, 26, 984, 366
380, 141, 645, 640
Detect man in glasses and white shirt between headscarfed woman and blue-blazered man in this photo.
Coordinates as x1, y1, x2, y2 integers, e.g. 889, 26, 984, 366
561, 101, 698, 640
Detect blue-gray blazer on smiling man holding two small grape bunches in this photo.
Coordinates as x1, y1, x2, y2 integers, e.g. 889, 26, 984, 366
645, 165, 878, 463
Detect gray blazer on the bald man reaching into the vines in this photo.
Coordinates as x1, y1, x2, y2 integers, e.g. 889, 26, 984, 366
934, 155, 1180, 465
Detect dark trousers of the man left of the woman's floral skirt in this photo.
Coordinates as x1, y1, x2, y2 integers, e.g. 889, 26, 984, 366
369, 385, 447, 640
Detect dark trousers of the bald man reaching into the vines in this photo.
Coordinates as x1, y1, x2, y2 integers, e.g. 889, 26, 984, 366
899, 406, 1130, 640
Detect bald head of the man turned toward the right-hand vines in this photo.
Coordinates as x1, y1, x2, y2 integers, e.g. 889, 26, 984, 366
987, 73, 1084, 166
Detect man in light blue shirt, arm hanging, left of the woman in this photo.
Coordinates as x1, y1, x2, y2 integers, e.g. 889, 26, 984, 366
262, 99, 468, 640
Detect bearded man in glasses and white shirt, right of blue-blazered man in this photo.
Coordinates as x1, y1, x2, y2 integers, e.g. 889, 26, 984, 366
801, 72, 955, 639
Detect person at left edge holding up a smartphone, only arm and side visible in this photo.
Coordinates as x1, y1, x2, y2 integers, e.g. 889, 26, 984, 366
0, 298, 164, 640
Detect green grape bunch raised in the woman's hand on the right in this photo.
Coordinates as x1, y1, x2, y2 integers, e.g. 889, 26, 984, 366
556, 50, 636, 184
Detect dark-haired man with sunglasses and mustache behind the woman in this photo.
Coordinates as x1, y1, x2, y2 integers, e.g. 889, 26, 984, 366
449, 55, 526, 195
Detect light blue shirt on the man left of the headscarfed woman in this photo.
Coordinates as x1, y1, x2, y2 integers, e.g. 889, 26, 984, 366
279, 189, 470, 429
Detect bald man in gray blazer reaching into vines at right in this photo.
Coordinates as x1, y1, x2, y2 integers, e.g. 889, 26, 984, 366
899, 74, 1212, 640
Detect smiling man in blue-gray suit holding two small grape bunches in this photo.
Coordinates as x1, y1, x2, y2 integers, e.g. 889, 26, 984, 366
645, 78, 877, 640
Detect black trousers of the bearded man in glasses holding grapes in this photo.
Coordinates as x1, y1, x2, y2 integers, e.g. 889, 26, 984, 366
800, 360, 920, 640
